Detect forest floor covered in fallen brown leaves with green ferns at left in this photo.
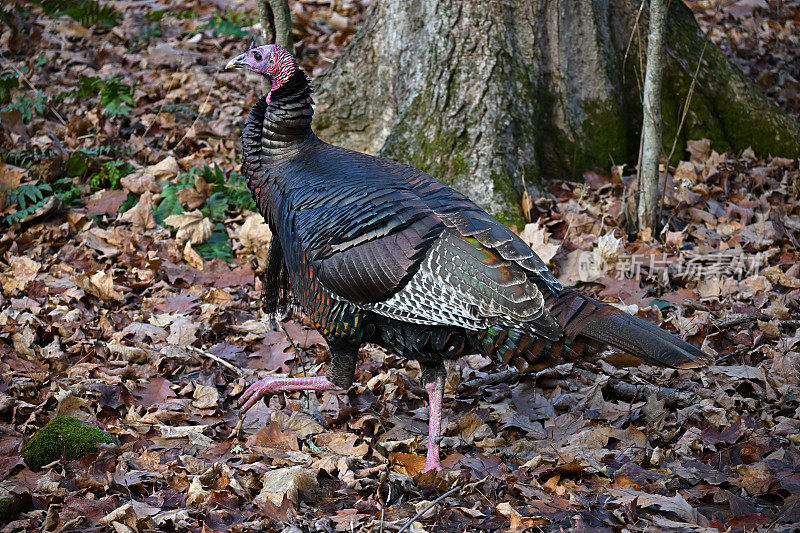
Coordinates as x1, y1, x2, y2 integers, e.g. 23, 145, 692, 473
0, 0, 800, 532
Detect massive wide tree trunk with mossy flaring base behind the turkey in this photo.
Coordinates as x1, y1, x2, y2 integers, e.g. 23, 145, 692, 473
315, 0, 800, 224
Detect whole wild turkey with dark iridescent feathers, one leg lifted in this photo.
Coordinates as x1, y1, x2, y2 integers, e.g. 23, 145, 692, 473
227, 45, 706, 471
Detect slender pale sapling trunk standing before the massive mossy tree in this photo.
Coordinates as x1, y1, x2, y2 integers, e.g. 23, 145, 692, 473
637, 0, 666, 234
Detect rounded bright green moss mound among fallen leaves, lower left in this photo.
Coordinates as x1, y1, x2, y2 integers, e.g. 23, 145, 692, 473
21, 416, 114, 470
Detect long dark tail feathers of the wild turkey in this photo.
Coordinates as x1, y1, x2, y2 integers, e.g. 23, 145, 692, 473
551, 291, 710, 368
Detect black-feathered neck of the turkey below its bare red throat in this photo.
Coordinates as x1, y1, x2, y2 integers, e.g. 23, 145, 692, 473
262, 69, 314, 150
